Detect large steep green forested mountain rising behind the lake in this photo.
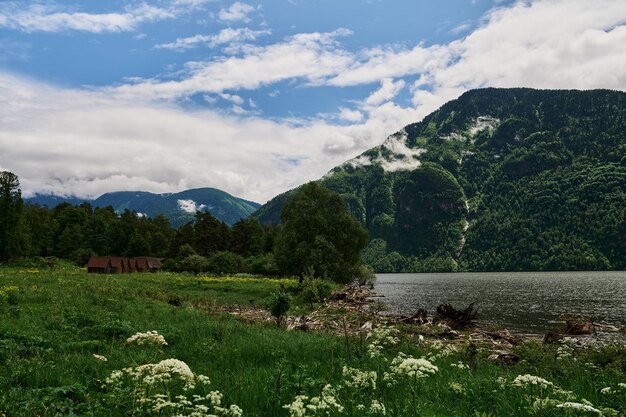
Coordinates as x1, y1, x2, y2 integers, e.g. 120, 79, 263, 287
255, 88, 626, 272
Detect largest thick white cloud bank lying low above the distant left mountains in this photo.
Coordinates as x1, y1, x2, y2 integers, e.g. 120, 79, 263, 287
0, 72, 416, 202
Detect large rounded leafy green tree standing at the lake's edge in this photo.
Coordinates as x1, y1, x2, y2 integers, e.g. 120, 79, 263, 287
275, 182, 368, 282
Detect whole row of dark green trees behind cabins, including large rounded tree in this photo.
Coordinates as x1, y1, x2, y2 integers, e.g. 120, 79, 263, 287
0, 171, 368, 282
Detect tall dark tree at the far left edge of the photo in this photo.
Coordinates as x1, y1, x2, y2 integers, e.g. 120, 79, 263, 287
0, 171, 23, 259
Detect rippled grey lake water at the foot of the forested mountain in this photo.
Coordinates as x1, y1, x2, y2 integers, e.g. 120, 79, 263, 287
375, 271, 626, 333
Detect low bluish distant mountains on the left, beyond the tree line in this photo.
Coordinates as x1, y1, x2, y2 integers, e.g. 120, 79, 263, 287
24, 188, 260, 227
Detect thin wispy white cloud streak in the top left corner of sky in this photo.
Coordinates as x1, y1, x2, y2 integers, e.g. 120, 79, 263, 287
0, 2, 175, 33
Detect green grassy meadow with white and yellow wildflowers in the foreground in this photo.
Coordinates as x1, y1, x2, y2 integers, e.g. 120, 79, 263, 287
0, 267, 626, 417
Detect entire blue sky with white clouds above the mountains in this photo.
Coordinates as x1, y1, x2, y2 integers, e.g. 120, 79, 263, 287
0, 0, 626, 203
